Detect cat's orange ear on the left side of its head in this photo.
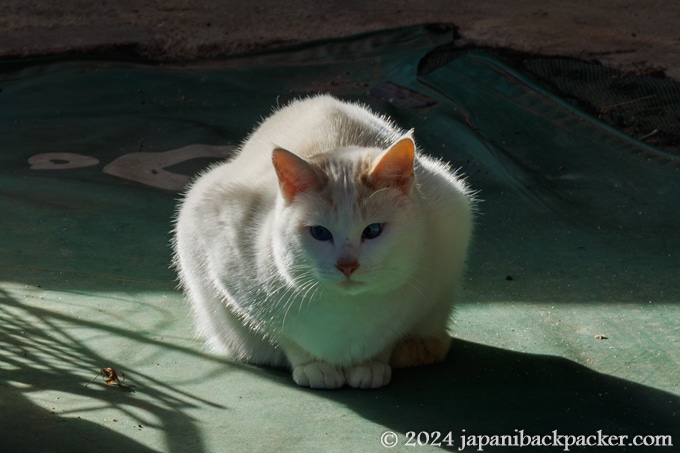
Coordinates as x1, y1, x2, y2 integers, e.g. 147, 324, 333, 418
272, 148, 321, 203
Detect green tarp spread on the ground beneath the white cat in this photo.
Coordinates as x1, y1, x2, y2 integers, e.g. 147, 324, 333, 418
0, 27, 680, 452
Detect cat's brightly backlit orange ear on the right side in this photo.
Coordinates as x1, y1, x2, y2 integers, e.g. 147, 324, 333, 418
370, 134, 416, 193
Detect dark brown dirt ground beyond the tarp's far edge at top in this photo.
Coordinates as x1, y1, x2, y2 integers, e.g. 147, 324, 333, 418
0, 0, 680, 80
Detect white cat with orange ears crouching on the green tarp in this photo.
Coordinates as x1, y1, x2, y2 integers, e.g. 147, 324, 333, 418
174, 96, 473, 388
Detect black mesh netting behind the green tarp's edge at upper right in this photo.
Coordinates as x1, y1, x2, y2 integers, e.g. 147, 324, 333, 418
419, 45, 680, 154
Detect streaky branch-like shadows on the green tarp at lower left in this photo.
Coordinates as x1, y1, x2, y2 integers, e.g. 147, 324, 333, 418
0, 290, 222, 452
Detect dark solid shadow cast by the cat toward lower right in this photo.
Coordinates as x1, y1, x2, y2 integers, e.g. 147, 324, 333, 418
300, 340, 680, 451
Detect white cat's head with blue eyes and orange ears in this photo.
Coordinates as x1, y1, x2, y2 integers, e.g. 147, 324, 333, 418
273, 135, 425, 294
